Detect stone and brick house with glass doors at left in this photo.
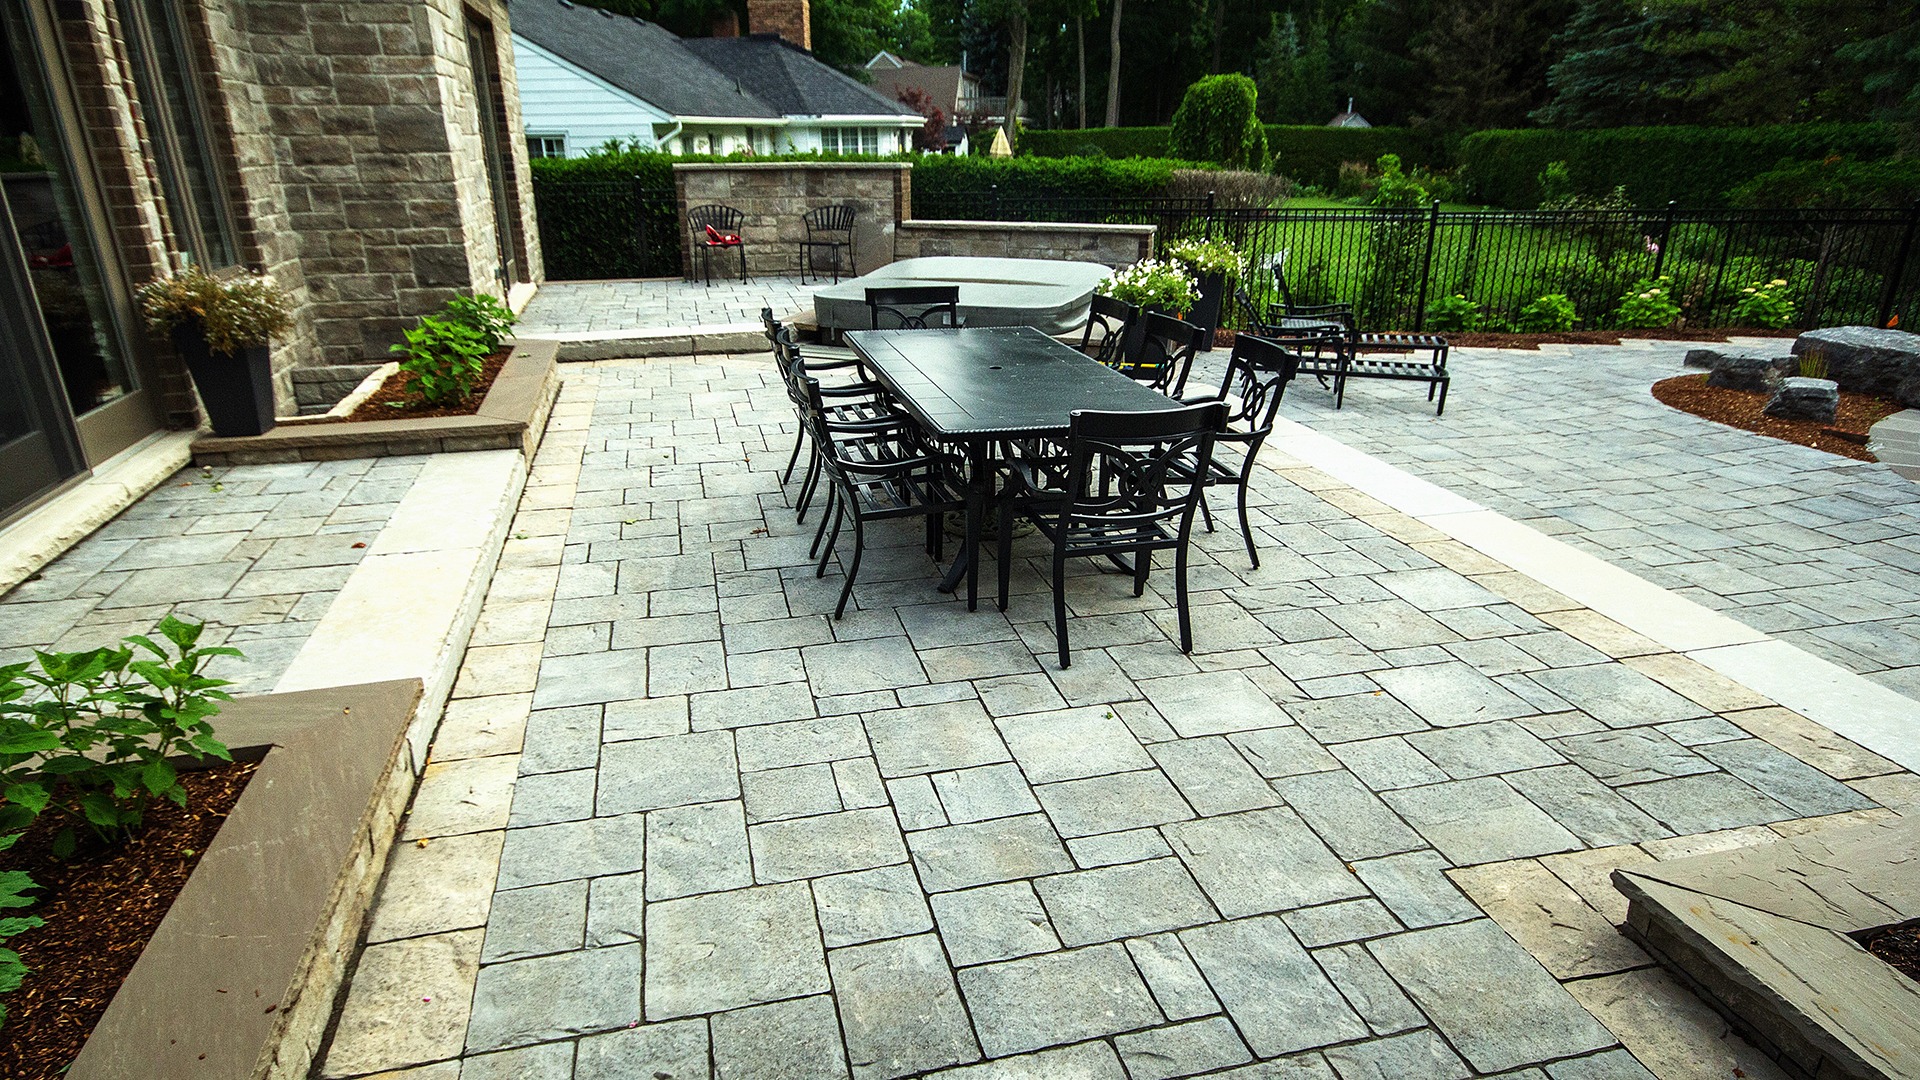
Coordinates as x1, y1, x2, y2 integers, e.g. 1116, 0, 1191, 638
0, 0, 541, 526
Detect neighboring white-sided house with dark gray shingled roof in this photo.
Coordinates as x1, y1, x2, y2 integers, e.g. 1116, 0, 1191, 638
513, 0, 925, 158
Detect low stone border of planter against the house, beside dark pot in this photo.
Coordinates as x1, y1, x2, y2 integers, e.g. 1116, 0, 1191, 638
194, 340, 561, 465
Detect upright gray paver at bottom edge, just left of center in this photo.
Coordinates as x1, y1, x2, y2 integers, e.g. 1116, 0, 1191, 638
828, 934, 979, 1080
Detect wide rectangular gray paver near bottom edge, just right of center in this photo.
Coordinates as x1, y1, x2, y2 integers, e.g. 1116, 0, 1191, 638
960, 945, 1162, 1057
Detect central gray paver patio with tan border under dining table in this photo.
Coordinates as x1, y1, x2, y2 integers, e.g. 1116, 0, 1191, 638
323, 357, 1920, 1080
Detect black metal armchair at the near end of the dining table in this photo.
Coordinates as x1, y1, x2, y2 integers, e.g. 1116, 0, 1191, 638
1000, 402, 1227, 667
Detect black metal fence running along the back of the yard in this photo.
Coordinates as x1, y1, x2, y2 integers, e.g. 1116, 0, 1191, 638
534, 177, 1920, 329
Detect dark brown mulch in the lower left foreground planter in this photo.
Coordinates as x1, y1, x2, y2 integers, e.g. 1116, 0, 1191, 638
0, 761, 257, 1080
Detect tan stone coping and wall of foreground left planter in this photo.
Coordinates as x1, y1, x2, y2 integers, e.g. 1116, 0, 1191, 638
65, 678, 420, 1080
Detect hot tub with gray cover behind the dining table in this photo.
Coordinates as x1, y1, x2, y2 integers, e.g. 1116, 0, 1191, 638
814, 256, 1112, 334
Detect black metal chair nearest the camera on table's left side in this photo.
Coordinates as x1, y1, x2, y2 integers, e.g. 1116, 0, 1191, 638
801, 377, 972, 619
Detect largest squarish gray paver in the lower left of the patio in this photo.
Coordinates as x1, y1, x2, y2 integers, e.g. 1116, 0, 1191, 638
647, 882, 828, 1020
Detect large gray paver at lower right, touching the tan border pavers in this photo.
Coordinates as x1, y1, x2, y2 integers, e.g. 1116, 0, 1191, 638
1367, 919, 1613, 1072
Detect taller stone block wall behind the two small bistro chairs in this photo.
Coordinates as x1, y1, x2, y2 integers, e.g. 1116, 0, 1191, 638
674, 161, 912, 277
